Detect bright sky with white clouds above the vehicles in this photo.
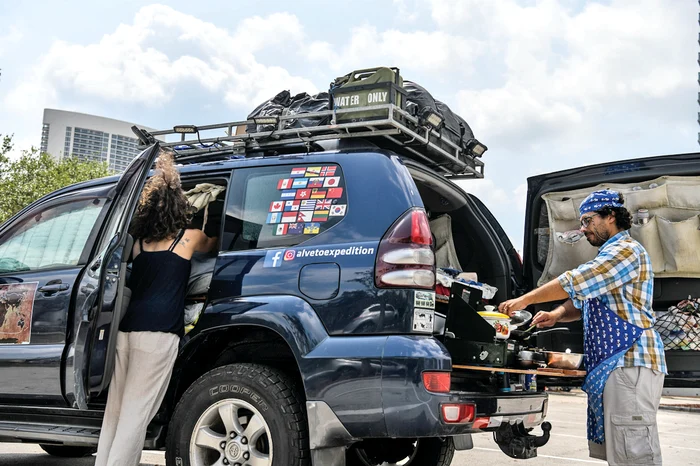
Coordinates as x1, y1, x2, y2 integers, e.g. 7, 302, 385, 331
0, 0, 700, 253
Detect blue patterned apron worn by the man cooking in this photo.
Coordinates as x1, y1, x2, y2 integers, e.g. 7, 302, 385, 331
581, 298, 645, 444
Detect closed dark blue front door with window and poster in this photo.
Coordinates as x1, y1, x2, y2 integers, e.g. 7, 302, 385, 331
0, 187, 108, 404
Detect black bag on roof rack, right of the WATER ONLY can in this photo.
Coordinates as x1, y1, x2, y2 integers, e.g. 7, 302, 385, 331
403, 81, 474, 149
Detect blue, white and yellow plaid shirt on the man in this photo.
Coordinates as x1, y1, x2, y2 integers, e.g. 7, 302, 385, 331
558, 231, 667, 374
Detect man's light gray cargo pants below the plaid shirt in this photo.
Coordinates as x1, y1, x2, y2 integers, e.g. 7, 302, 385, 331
588, 367, 664, 466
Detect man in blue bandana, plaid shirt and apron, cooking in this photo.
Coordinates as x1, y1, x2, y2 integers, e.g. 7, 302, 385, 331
499, 189, 667, 465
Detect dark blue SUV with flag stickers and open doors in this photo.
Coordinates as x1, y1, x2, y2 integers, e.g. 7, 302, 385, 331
0, 109, 548, 466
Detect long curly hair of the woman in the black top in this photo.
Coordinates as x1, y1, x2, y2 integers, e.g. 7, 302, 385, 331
129, 150, 193, 242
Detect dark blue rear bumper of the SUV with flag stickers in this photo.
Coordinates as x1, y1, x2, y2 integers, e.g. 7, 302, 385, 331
305, 335, 547, 443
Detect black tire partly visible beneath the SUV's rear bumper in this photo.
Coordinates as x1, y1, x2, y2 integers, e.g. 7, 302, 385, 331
345, 437, 455, 466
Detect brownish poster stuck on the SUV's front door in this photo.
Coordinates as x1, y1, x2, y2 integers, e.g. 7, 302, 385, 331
0, 282, 38, 345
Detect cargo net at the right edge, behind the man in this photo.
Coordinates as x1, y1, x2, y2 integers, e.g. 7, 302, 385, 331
655, 298, 700, 351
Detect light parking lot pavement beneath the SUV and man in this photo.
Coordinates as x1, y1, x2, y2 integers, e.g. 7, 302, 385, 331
0, 392, 700, 466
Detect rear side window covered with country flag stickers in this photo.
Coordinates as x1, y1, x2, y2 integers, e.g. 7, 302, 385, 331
222, 165, 348, 250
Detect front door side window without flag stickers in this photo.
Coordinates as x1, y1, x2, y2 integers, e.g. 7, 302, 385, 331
0, 198, 105, 273
